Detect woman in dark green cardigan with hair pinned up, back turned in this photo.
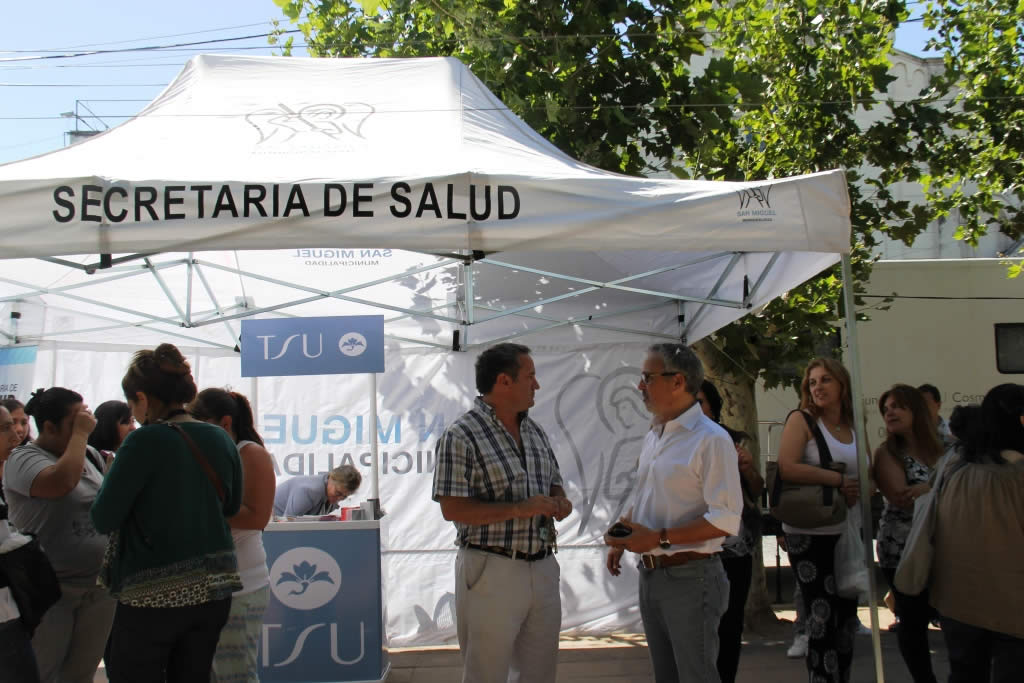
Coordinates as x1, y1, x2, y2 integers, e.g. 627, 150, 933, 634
92, 344, 243, 683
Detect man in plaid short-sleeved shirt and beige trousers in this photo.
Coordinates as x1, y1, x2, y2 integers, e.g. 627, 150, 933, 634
433, 343, 572, 683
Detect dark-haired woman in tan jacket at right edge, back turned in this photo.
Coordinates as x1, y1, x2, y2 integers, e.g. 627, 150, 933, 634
929, 384, 1024, 683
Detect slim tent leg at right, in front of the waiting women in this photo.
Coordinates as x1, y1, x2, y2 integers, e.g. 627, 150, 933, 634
843, 254, 886, 683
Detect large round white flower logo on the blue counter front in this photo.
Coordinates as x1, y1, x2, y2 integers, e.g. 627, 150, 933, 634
270, 547, 341, 609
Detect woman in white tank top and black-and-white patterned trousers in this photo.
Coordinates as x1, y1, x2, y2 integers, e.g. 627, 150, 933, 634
778, 358, 859, 682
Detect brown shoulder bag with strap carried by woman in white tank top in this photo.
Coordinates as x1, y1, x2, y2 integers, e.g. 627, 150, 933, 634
766, 411, 846, 528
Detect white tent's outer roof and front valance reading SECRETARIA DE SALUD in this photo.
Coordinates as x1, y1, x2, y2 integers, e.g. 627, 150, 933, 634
0, 55, 850, 258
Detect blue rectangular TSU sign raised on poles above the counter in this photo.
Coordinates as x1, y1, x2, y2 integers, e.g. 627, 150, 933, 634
242, 315, 384, 377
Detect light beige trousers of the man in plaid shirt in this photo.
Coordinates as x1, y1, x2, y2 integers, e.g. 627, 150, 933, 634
455, 548, 562, 683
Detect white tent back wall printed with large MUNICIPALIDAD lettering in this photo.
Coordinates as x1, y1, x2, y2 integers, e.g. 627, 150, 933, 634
36, 343, 649, 646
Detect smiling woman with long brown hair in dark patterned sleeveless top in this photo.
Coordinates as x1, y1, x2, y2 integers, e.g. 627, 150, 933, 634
872, 384, 942, 683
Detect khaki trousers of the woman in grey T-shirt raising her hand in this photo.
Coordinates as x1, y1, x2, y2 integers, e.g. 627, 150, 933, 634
32, 584, 118, 683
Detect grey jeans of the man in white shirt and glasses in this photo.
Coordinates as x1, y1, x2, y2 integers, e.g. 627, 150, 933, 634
640, 555, 729, 683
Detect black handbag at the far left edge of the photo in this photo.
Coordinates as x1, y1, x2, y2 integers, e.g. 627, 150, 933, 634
0, 537, 60, 638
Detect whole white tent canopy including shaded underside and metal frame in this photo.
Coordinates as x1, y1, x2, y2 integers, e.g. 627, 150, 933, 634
0, 55, 880, 671
